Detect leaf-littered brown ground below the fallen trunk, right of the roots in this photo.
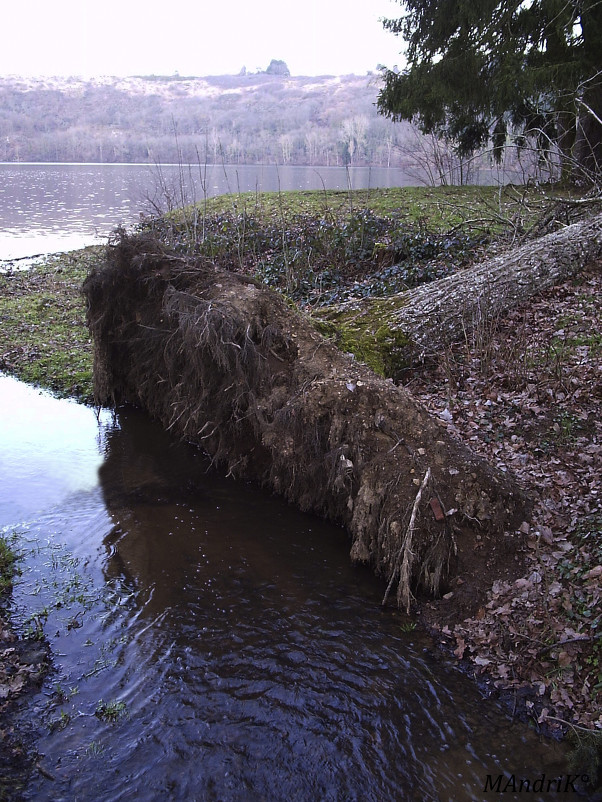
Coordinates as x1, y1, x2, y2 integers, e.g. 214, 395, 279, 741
409, 263, 602, 728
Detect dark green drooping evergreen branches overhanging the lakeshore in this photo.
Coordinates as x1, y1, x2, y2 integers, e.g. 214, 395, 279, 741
378, 0, 602, 177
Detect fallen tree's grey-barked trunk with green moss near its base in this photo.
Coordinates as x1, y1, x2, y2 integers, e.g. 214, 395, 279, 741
318, 215, 602, 377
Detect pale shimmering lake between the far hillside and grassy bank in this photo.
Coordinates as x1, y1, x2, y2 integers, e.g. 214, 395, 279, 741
0, 163, 415, 260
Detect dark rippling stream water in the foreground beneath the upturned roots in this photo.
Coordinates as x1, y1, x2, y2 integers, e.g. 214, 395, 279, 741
0, 377, 567, 802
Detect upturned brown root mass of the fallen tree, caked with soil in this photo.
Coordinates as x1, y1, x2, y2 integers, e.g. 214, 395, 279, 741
84, 231, 528, 609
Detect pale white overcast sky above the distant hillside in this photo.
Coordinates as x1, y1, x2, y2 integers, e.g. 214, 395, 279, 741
0, 0, 403, 77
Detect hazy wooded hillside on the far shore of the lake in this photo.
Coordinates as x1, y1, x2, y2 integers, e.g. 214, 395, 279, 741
0, 73, 408, 166
